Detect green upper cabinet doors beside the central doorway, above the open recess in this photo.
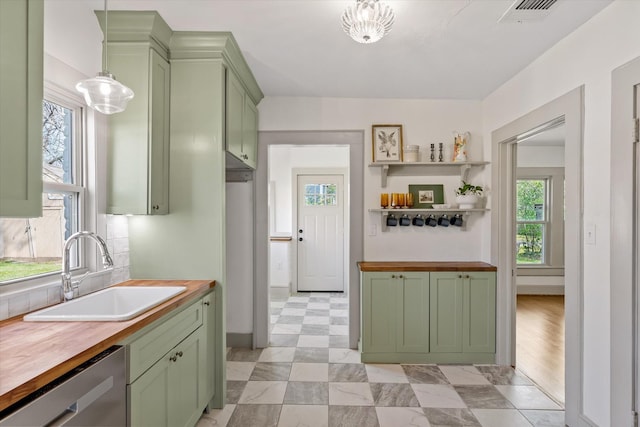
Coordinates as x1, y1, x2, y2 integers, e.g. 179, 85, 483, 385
226, 69, 258, 169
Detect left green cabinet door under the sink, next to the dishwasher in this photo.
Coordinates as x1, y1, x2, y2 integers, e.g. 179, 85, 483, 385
127, 354, 171, 427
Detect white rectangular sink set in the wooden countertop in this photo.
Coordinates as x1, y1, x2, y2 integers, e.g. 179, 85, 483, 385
24, 286, 187, 322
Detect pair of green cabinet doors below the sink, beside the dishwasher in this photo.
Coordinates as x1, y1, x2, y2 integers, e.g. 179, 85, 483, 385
129, 327, 206, 427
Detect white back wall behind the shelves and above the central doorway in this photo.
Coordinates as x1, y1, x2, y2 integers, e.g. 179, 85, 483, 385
259, 97, 482, 261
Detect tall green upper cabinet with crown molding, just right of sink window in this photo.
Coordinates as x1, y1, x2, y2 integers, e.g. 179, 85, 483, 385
96, 11, 172, 215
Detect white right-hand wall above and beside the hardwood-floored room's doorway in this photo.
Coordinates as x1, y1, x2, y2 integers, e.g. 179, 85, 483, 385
482, 0, 640, 427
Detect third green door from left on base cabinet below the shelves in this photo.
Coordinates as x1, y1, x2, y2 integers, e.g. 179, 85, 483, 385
429, 272, 463, 353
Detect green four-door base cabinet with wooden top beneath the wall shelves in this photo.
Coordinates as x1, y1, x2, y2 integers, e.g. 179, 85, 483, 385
358, 262, 496, 363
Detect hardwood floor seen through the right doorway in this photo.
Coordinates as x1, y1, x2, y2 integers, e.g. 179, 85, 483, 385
516, 295, 564, 404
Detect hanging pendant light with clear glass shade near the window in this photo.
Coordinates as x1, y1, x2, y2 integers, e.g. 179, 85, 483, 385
76, 0, 133, 114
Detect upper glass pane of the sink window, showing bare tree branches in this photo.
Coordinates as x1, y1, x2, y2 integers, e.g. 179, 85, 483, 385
42, 100, 74, 184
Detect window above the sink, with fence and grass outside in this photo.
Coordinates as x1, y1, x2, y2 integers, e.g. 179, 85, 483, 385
0, 96, 84, 282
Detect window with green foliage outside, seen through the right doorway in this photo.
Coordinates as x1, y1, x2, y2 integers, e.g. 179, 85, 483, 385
516, 179, 548, 264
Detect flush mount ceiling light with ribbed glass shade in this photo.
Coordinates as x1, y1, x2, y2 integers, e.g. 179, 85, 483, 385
342, 0, 395, 43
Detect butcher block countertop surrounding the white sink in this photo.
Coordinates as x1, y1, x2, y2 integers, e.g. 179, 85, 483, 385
0, 280, 215, 411
